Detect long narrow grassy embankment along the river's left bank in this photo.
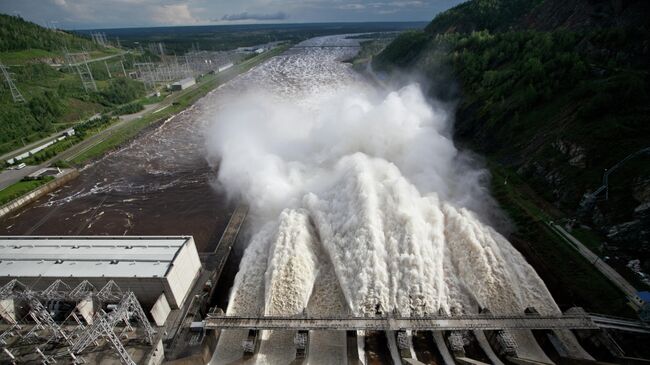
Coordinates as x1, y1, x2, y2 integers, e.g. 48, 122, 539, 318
70, 45, 289, 165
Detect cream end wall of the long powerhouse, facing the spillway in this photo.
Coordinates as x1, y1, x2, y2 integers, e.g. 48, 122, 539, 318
165, 238, 201, 309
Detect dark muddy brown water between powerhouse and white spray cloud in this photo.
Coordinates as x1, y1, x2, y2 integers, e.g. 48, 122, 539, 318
0, 105, 234, 251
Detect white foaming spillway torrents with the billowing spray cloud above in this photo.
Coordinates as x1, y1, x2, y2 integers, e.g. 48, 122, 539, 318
206, 37, 559, 363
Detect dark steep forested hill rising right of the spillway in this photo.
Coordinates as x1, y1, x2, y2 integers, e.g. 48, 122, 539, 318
373, 0, 650, 296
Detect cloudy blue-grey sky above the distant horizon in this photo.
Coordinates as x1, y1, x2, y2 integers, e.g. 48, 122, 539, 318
0, 0, 463, 29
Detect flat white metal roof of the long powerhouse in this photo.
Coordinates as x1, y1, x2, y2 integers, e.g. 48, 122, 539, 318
0, 236, 190, 277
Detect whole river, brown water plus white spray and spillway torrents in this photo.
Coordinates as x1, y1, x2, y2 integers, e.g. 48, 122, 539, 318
0, 36, 588, 364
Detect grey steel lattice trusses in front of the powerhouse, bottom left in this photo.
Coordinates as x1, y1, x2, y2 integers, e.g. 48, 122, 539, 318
0, 279, 156, 365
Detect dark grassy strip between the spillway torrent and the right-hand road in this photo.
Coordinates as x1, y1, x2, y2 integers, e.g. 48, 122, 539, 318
489, 162, 635, 317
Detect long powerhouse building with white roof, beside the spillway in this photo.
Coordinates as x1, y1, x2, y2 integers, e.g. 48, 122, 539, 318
0, 236, 201, 322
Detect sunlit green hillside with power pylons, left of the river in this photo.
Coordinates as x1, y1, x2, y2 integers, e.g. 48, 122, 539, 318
0, 14, 144, 154
